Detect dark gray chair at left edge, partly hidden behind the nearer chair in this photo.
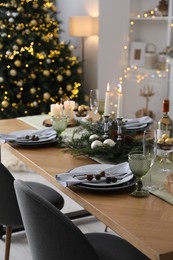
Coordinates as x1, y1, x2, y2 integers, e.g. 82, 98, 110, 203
0, 163, 64, 260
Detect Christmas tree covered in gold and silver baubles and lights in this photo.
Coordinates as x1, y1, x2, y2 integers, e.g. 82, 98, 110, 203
0, 0, 82, 118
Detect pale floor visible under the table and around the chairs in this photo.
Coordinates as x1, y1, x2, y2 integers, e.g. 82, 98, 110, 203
0, 171, 112, 260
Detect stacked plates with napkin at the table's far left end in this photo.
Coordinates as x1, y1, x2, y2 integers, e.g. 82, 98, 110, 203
0, 128, 57, 146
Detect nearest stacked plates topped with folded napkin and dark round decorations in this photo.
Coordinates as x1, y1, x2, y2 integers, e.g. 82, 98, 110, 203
56, 162, 135, 190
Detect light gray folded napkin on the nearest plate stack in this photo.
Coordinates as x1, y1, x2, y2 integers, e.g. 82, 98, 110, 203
56, 162, 131, 187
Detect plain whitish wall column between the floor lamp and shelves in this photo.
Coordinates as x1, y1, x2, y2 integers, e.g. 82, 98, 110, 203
98, 0, 130, 99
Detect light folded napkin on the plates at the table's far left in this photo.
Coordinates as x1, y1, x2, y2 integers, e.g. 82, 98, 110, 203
0, 128, 56, 142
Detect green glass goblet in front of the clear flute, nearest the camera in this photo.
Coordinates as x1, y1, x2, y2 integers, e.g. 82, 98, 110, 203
128, 151, 151, 197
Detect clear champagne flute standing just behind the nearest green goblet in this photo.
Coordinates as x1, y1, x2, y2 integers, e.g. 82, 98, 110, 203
143, 129, 157, 191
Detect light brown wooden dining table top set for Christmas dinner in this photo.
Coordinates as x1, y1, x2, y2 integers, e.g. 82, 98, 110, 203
0, 119, 173, 260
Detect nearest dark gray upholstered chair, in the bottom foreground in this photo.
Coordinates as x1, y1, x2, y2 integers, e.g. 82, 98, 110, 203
14, 180, 148, 260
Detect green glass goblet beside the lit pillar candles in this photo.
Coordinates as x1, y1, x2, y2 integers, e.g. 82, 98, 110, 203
52, 115, 68, 142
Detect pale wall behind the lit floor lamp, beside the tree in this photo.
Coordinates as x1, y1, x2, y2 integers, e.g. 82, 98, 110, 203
56, 0, 99, 100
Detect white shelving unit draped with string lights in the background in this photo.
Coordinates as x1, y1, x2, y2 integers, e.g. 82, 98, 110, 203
124, 0, 173, 121
